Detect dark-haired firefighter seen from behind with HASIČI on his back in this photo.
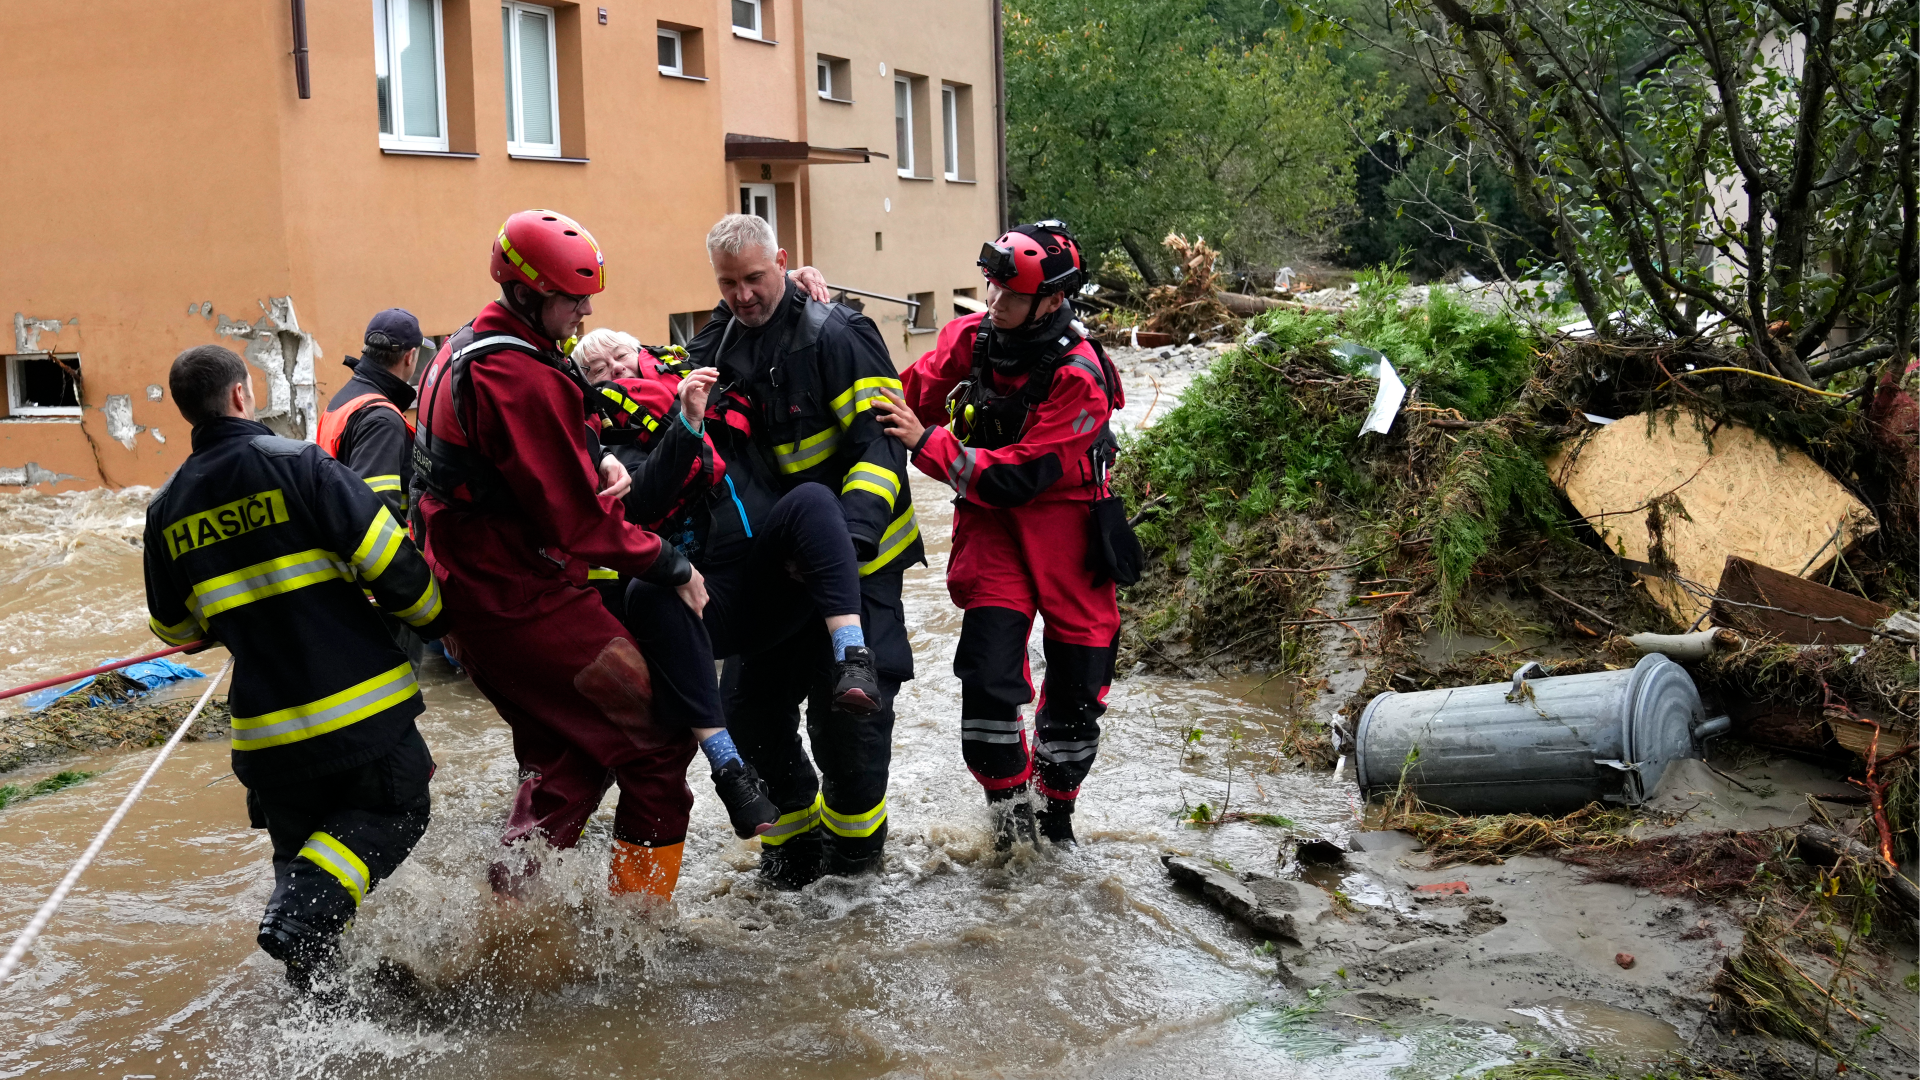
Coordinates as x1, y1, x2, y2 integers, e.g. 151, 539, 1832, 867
146, 346, 445, 988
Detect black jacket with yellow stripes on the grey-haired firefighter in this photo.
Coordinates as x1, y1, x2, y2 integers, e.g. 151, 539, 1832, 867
687, 282, 925, 577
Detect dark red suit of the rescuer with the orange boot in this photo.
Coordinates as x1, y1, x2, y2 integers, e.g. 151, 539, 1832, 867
417, 302, 695, 886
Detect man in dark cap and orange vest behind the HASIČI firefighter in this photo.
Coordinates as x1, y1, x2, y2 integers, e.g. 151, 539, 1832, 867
315, 307, 422, 521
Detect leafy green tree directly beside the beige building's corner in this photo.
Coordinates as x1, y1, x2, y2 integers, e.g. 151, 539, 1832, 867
1006, 0, 1394, 276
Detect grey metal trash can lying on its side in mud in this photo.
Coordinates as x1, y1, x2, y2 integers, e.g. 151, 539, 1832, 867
1354, 653, 1724, 813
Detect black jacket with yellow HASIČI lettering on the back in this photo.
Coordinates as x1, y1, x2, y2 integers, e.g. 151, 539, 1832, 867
146, 417, 445, 786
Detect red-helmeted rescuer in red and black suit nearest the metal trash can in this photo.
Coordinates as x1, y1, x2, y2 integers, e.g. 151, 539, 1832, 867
876, 221, 1131, 849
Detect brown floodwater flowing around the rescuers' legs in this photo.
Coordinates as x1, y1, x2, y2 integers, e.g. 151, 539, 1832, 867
0, 468, 1559, 1080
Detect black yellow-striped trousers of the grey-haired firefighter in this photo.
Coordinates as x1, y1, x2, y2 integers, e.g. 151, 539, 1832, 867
722, 571, 914, 861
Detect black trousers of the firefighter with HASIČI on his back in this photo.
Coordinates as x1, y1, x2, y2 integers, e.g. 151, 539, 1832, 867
248, 724, 434, 955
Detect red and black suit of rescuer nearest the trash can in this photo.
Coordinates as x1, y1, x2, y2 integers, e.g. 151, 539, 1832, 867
902, 307, 1123, 813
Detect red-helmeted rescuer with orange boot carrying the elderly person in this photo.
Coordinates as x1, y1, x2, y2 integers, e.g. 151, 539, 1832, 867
415, 209, 778, 897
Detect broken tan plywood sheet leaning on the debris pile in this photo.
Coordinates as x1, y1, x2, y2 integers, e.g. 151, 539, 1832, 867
1548, 409, 1876, 625
